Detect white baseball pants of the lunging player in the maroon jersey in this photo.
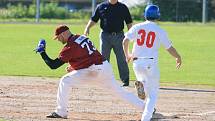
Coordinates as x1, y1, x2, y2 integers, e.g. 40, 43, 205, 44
55, 61, 145, 117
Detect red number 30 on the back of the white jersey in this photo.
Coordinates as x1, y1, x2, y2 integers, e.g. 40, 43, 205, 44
137, 29, 156, 48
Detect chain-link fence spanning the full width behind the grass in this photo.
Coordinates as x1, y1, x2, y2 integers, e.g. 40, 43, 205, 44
0, 0, 215, 22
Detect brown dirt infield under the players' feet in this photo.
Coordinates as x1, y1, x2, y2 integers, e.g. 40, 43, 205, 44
0, 76, 215, 121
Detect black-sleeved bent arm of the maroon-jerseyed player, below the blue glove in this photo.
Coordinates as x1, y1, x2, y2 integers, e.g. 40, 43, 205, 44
40, 52, 65, 69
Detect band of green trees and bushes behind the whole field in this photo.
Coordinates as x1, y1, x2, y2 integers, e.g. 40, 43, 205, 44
0, 0, 215, 22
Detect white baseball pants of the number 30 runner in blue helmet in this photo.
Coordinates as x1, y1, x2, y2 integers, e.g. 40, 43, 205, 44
133, 59, 160, 121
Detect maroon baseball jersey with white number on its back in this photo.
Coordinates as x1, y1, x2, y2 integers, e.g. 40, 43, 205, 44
59, 35, 104, 70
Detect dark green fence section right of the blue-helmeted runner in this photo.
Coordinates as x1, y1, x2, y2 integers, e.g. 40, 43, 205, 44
152, 0, 215, 22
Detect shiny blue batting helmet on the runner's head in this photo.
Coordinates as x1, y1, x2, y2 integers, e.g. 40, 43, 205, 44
144, 5, 160, 20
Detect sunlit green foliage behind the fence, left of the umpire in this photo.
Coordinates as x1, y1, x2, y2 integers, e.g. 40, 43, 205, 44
0, 2, 91, 19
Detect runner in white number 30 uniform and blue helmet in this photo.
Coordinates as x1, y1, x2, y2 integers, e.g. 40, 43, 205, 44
123, 5, 181, 121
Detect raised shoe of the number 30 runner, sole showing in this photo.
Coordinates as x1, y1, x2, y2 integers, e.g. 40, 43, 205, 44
134, 81, 146, 100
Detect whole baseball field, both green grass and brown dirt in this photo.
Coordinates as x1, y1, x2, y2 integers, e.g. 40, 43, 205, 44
0, 23, 215, 121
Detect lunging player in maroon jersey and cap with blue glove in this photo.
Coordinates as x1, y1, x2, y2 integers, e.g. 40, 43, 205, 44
35, 25, 144, 118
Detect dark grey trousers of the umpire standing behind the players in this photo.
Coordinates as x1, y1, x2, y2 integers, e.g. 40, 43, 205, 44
100, 31, 129, 83
